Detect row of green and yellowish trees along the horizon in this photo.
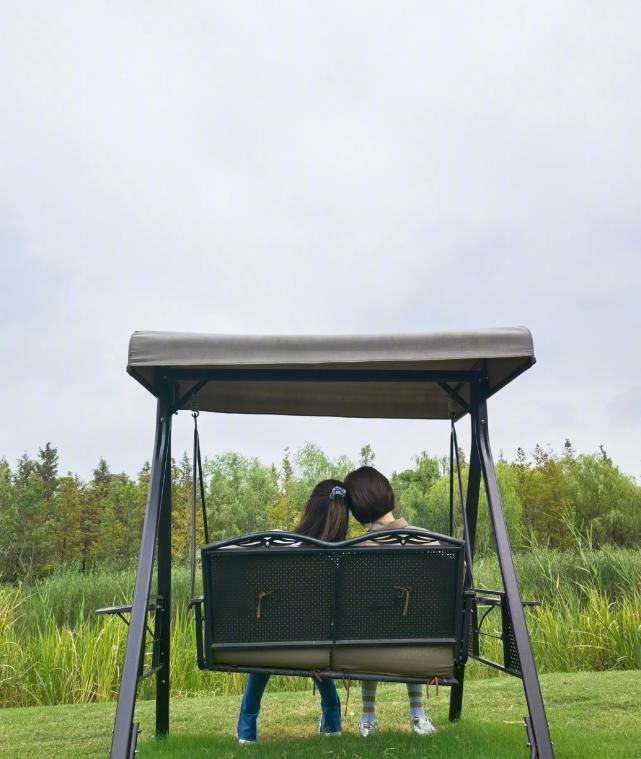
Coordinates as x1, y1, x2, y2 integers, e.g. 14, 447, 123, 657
0, 441, 641, 581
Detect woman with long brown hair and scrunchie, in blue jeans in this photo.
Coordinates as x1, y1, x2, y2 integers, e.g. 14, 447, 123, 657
236, 480, 349, 743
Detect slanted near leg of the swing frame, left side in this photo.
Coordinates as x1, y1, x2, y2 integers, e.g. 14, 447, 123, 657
110, 393, 171, 759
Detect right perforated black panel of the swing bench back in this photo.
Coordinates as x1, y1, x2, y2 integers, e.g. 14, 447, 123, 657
336, 546, 461, 642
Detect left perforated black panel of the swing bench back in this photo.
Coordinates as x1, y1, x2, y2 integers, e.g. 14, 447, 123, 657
203, 548, 334, 644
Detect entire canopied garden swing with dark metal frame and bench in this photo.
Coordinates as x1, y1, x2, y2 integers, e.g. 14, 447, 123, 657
98, 327, 553, 759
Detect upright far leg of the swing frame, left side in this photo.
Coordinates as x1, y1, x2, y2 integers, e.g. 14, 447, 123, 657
156, 424, 171, 738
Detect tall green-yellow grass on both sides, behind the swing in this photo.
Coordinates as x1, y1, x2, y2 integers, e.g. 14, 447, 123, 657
0, 543, 641, 706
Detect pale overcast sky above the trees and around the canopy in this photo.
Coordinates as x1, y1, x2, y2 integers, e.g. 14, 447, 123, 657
0, 0, 641, 477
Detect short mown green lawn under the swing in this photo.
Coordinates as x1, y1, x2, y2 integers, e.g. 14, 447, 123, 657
0, 671, 641, 759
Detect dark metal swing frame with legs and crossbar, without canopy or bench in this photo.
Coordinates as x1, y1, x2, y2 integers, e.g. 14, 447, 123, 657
103, 333, 554, 759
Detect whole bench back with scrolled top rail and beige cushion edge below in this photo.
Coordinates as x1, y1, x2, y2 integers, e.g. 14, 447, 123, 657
201, 529, 464, 677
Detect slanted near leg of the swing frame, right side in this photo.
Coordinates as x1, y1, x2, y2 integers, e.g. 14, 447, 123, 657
473, 397, 554, 759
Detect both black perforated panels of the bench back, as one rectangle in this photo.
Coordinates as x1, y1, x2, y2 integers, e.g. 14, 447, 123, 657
202, 544, 463, 647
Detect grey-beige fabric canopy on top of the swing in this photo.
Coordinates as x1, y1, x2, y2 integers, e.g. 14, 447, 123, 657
127, 327, 535, 419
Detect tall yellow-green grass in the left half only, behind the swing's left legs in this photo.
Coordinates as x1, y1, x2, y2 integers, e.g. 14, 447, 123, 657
0, 566, 324, 707
